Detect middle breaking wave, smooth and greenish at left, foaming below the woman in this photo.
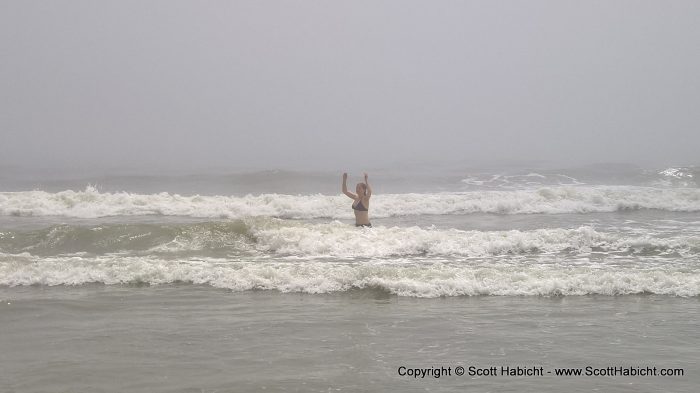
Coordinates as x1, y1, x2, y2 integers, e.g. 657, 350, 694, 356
0, 218, 700, 259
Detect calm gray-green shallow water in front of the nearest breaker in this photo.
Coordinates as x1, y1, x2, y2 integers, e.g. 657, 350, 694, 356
0, 285, 700, 392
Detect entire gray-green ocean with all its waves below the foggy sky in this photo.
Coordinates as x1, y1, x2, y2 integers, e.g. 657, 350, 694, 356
0, 165, 700, 392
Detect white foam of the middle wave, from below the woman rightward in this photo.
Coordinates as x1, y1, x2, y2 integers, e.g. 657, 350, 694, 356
250, 222, 700, 258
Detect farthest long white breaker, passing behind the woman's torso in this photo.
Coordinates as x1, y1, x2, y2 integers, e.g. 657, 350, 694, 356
0, 186, 700, 219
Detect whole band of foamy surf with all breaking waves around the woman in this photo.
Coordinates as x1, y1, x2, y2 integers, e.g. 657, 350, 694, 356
0, 168, 700, 297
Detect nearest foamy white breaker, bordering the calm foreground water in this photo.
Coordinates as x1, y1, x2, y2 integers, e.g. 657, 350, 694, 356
0, 255, 700, 297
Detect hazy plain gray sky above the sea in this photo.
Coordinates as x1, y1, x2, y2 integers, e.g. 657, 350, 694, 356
0, 0, 700, 170
